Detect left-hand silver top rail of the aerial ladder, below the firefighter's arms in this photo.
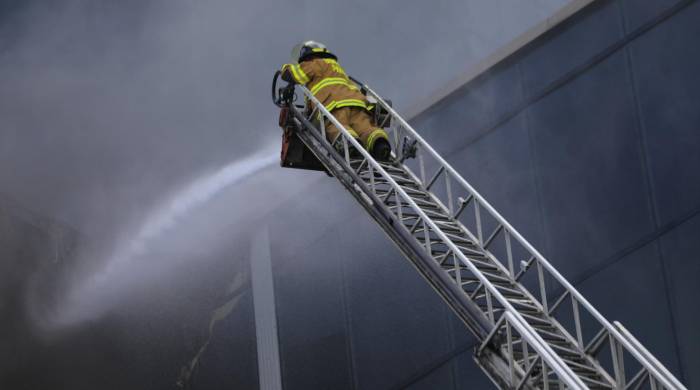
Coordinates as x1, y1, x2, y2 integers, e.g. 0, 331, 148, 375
299, 86, 588, 389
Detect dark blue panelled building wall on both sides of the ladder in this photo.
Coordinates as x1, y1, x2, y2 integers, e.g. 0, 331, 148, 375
254, 0, 700, 389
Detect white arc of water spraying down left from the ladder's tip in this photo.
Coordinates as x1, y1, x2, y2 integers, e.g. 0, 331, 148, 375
43, 143, 278, 325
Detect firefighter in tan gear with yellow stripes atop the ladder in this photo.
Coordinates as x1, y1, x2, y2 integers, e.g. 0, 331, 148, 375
282, 41, 391, 161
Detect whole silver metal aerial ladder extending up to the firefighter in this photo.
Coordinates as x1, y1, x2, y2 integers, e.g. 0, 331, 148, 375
272, 72, 686, 390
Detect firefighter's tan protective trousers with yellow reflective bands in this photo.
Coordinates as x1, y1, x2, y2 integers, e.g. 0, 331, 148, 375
326, 107, 389, 150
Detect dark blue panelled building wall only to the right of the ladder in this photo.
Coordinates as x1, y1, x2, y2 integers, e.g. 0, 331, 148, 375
415, 1, 700, 388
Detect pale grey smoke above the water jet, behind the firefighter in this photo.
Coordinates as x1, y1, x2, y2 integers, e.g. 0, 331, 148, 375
0, 0, 568, 244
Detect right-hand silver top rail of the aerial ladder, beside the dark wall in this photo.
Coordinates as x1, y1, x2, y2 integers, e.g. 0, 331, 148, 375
358, 84, 687, 390
